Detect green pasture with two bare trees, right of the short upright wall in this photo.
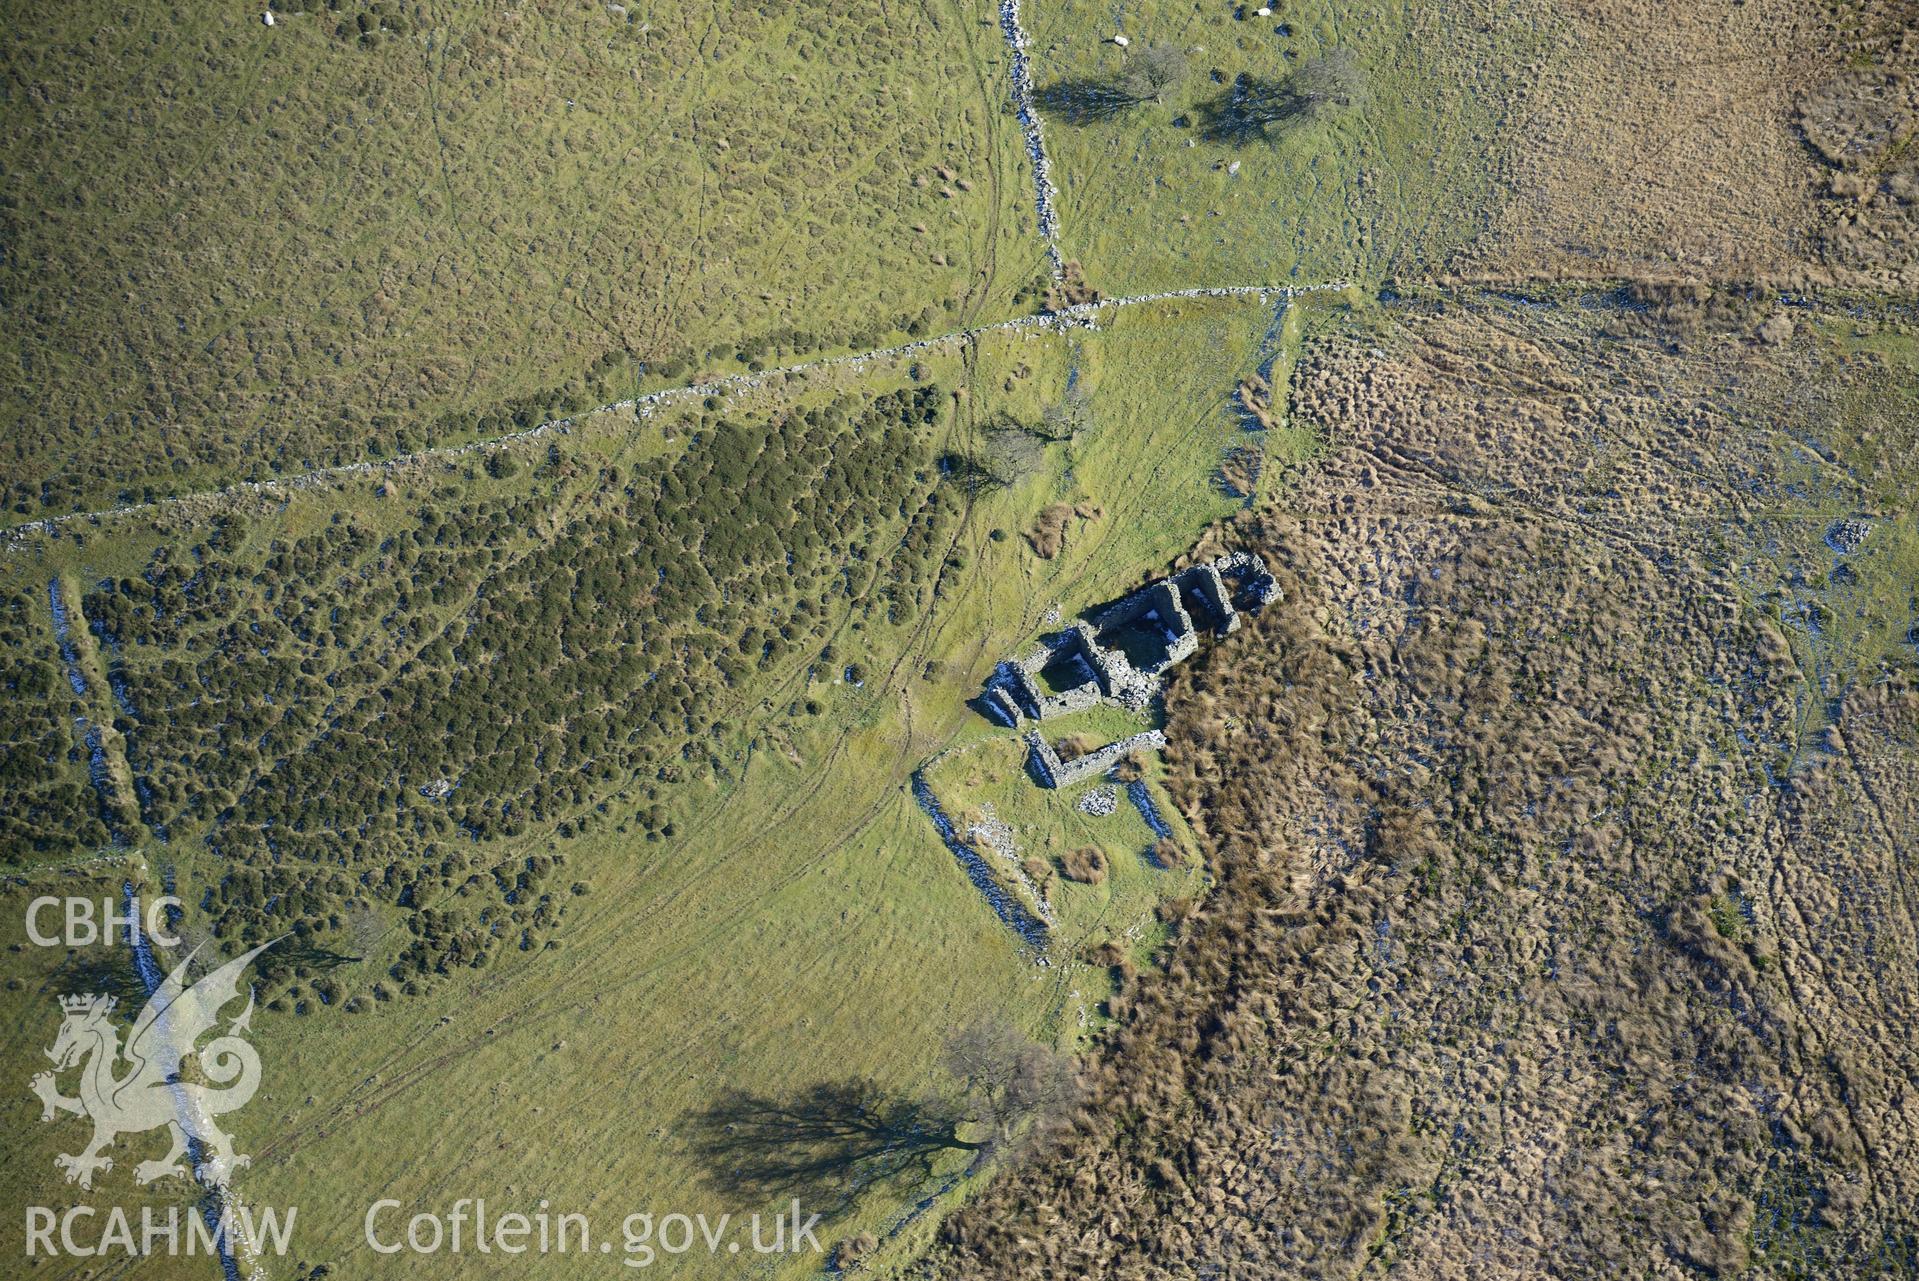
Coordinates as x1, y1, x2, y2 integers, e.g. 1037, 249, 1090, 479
1031, 0, 1547, 293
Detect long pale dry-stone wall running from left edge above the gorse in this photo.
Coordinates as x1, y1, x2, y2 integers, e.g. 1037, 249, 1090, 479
4, 282, 1347, 550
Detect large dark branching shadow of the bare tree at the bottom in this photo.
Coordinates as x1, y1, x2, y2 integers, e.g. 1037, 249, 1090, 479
691, 1078, 984, 1212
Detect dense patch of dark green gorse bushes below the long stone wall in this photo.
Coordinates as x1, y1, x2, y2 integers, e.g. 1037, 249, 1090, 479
48, 385, 961, 1004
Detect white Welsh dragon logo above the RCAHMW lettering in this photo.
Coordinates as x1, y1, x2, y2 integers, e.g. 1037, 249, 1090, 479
33, 940, 278, 1189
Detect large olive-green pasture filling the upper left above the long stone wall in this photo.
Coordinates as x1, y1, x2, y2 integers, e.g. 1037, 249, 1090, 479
0, 0, 1042, 514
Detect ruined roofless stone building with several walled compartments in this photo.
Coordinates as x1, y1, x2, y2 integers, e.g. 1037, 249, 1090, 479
981, 552, 1278, 788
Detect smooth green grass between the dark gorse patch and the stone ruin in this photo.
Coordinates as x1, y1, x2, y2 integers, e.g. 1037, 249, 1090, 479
0, 301, 1304, 1275
